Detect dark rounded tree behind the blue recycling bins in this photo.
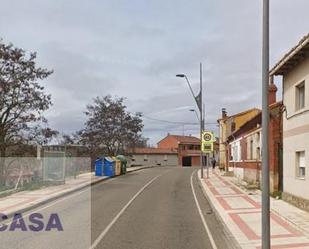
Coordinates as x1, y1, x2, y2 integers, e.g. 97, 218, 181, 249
81, 95, 143, 155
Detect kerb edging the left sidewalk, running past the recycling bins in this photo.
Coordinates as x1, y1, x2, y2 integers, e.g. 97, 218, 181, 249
6, 166, 154, 218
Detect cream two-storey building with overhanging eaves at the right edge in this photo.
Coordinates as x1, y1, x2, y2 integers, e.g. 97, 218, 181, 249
270, 34, 309, 210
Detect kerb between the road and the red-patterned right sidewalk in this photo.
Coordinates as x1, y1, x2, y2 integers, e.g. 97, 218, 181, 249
197, 170, 241, 249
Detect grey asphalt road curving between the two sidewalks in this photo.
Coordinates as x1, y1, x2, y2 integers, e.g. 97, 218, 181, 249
0, 167, 231, 249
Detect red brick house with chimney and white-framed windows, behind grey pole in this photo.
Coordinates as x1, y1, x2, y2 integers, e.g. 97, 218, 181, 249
228, 82, 283, 192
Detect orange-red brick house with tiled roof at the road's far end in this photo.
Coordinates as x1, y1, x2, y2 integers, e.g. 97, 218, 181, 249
158, 134, 201, 166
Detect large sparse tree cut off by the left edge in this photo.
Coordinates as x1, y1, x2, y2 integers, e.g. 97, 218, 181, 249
0, 40, 52, 185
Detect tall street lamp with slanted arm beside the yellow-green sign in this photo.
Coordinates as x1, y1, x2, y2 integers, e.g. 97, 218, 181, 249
176, 63, 204, 178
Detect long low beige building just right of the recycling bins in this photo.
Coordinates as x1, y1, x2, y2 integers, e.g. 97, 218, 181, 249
128, 148, 178, 166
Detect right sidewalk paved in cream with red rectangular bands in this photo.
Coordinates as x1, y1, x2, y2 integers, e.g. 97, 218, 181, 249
199, 170, 309, 249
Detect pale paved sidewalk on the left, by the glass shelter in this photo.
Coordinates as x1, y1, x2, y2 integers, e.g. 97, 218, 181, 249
0, 167, 149, 217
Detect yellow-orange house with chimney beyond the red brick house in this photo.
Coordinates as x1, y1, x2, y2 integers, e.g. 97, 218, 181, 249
218, 108, 260, 170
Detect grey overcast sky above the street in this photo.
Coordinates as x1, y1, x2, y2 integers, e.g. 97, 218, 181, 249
0, 0, 309, 144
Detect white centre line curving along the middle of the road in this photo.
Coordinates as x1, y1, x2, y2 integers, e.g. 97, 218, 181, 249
90, 175, 161, 249
